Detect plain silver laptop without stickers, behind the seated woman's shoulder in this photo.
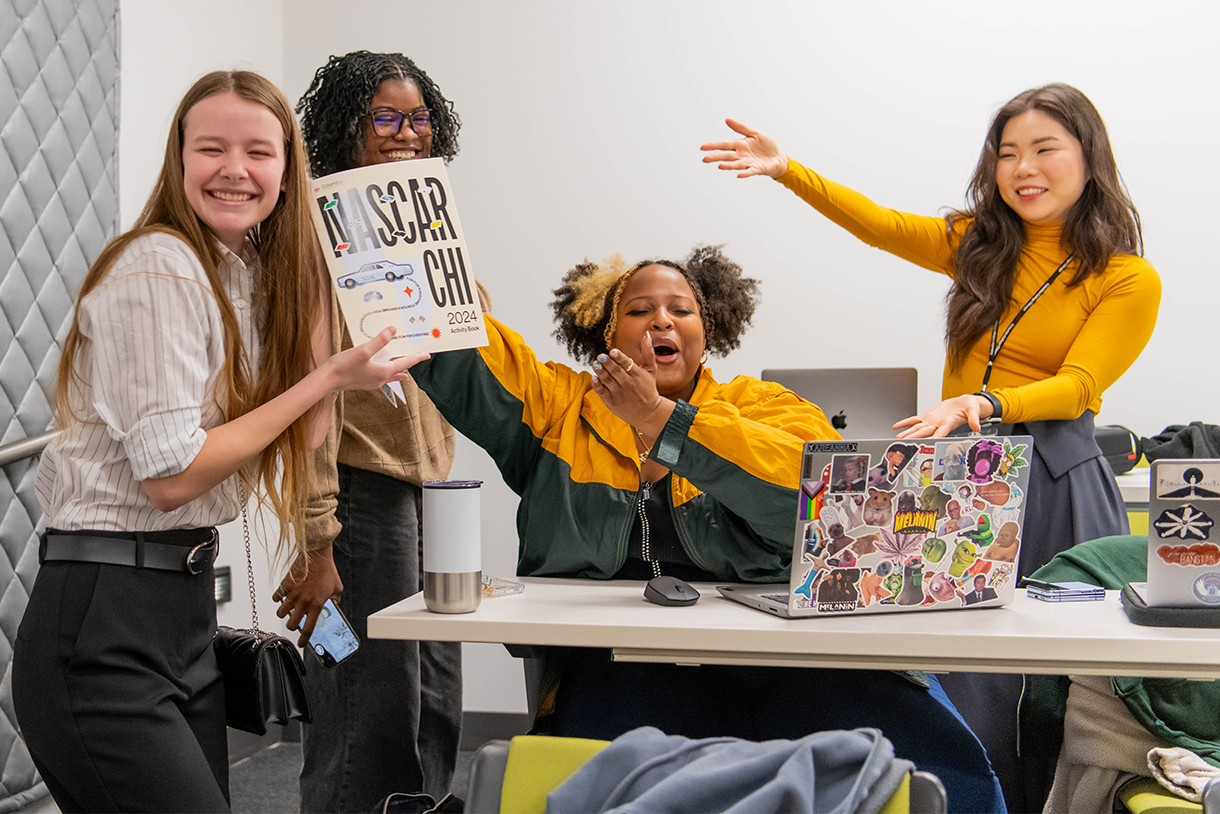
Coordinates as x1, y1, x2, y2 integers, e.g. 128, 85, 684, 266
761, 367, 919, 438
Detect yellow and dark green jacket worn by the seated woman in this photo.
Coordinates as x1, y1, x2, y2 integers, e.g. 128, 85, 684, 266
411, 317, 838, 582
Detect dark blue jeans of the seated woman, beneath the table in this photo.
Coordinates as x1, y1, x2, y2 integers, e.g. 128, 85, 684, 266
551, 649, 1004, 814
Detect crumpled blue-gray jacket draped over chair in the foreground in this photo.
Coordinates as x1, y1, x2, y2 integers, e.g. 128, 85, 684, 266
547, 726, 915, 814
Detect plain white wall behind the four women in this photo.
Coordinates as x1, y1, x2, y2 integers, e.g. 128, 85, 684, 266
121, 0, 1220, 711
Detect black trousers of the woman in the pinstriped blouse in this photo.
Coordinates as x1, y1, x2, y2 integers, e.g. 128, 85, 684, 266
12, 563, 229, 814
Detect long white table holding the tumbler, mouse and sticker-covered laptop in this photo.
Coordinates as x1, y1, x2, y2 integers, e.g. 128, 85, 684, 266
368, 578, 1220, 679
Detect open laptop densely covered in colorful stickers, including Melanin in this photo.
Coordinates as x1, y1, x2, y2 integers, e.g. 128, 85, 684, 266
717, 436, 1033, 618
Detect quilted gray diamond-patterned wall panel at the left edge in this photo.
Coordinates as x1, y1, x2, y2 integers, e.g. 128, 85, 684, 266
0, 0, 118, 812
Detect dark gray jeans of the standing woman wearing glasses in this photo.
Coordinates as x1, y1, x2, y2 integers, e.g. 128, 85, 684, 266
300, 464, 461, 814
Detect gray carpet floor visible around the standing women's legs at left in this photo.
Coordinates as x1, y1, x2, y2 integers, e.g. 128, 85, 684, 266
229, 742, 475, 814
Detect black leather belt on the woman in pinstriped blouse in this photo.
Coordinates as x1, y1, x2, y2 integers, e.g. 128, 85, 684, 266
38, 528, 221, 574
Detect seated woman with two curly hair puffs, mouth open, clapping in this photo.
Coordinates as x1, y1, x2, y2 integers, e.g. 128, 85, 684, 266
411, 248, 1002, 812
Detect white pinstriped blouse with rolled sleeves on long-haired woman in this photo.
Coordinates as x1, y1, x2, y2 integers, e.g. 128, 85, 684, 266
35, 233, 261, 531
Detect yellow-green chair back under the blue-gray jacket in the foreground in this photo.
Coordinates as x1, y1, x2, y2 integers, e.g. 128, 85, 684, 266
465, 735, 948, 814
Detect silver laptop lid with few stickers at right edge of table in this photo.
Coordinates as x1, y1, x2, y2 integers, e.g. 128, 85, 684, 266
1146, 459, 1220, 608
